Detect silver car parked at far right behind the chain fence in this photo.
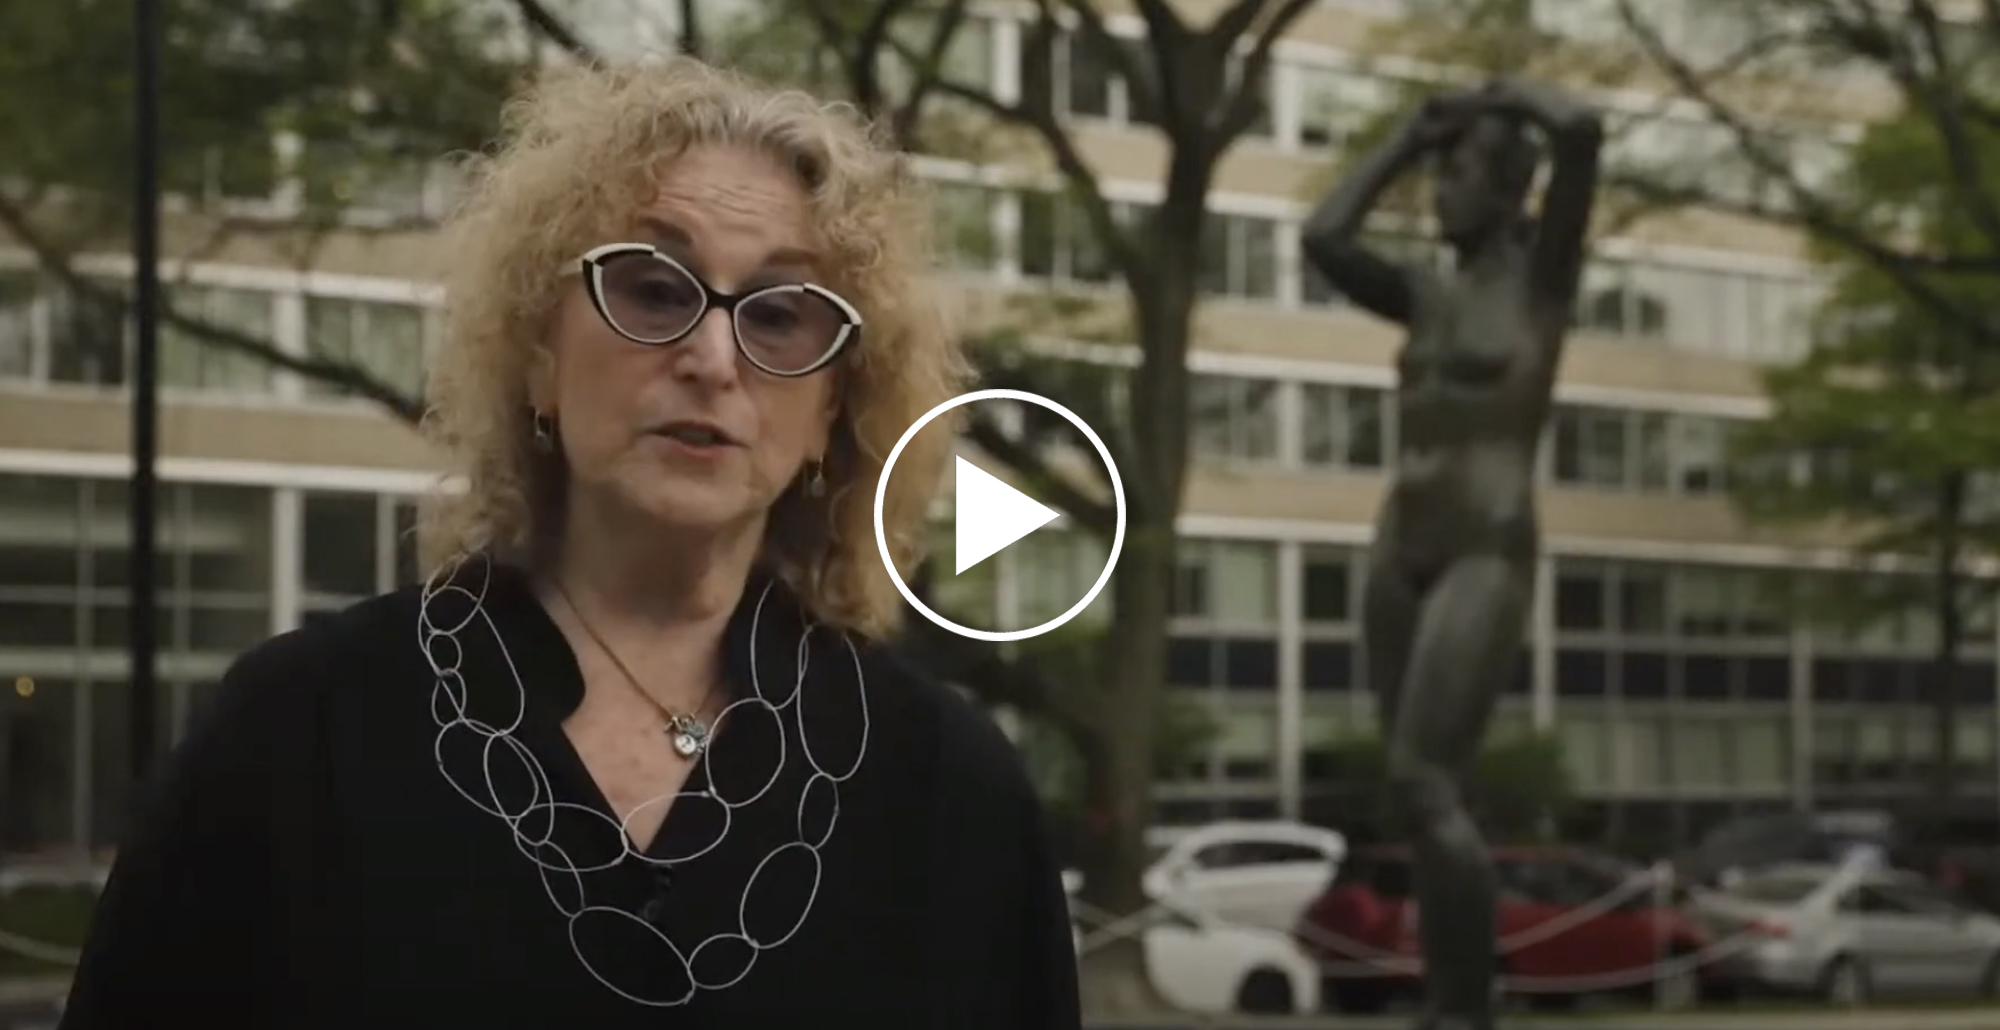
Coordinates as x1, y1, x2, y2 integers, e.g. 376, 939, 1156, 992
1694, 862, 2000, 1006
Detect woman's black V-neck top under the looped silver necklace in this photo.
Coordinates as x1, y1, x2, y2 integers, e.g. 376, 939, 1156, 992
62, 560, 1080, 1030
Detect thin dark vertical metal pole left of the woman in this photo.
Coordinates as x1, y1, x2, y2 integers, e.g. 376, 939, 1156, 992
126, 0, 160, 798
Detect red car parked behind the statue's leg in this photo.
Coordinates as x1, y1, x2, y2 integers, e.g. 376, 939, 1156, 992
1298, 848, 1710, 1012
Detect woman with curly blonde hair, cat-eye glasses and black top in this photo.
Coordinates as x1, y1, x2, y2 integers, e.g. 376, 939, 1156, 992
64, 60, 1078, 1030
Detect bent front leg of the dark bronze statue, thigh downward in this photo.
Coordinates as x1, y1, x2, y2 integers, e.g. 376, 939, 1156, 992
1388, 556, 1534, 1030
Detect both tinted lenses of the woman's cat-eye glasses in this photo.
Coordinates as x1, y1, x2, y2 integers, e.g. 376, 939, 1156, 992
598, 254, 846, 372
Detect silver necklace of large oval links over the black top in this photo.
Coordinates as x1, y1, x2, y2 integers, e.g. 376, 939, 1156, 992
416, 554, 870, 1008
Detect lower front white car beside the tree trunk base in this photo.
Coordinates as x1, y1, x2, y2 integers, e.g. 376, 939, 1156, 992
1072, 906, 1320, 1014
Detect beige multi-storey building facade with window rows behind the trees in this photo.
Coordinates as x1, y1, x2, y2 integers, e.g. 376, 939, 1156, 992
0, 4, 2000, 864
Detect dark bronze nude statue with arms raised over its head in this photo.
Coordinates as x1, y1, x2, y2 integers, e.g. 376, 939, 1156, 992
1304, 80, 1604, 1030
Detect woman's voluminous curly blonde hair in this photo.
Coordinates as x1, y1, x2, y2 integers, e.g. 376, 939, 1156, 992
420, 58, 970, 638
